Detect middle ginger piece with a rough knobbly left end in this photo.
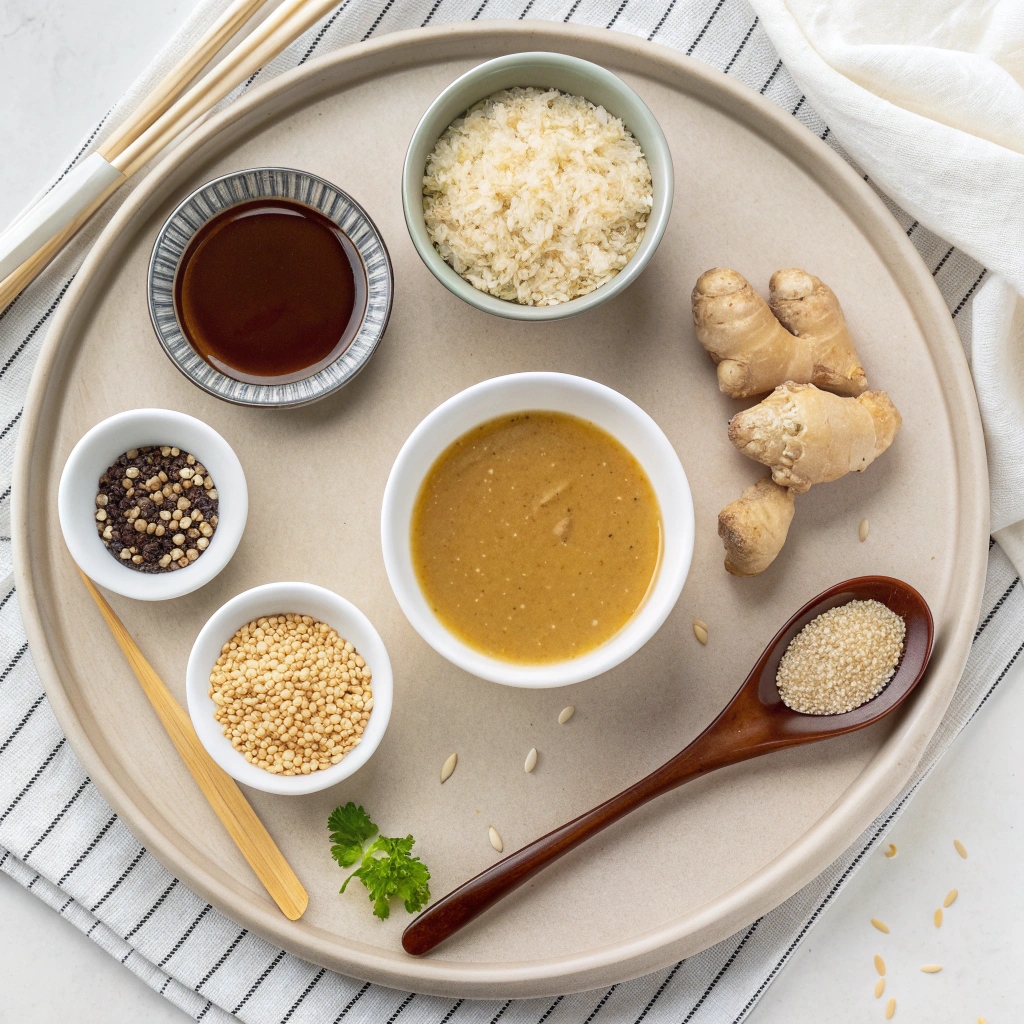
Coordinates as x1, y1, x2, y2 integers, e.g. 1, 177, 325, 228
729, 381, 903, 494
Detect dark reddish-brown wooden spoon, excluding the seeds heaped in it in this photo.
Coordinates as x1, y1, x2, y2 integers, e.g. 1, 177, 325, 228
401, 577, 935, 955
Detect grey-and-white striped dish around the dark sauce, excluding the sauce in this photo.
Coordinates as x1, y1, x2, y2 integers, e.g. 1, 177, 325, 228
148, 167, 394, 409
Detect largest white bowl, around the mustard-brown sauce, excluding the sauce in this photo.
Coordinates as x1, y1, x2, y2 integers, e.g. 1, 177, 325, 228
381, 373, 693, 687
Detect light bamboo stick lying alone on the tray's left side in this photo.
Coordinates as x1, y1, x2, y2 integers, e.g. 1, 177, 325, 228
78, 569, 309, 921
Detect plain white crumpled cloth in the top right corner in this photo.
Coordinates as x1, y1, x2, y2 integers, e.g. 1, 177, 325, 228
751, 0, 1024, 570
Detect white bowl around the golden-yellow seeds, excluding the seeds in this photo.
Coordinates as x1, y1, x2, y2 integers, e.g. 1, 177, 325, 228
185, 583, 394, 796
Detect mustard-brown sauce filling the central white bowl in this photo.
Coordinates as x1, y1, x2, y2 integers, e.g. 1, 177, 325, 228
412, 412, 662, 664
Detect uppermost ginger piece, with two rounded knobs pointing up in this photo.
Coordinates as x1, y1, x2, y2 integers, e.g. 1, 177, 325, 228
690, 267, 867, 398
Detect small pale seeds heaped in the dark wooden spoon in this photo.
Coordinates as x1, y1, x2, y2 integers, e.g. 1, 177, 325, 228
775, 601, 906, 715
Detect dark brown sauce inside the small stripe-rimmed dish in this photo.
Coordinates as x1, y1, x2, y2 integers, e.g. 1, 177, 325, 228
174, 199, 367, 384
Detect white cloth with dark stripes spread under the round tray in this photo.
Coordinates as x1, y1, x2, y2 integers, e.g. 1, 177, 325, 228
0, 0, 1024, 1024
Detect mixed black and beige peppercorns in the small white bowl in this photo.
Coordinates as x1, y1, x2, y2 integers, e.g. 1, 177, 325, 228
95, 444, 219, 572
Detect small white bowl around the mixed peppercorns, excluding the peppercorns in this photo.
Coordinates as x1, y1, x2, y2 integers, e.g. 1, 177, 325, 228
57, 409, 249, 601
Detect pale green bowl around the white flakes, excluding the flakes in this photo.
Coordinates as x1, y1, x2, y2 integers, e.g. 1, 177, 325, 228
401, 52, 673, 321
